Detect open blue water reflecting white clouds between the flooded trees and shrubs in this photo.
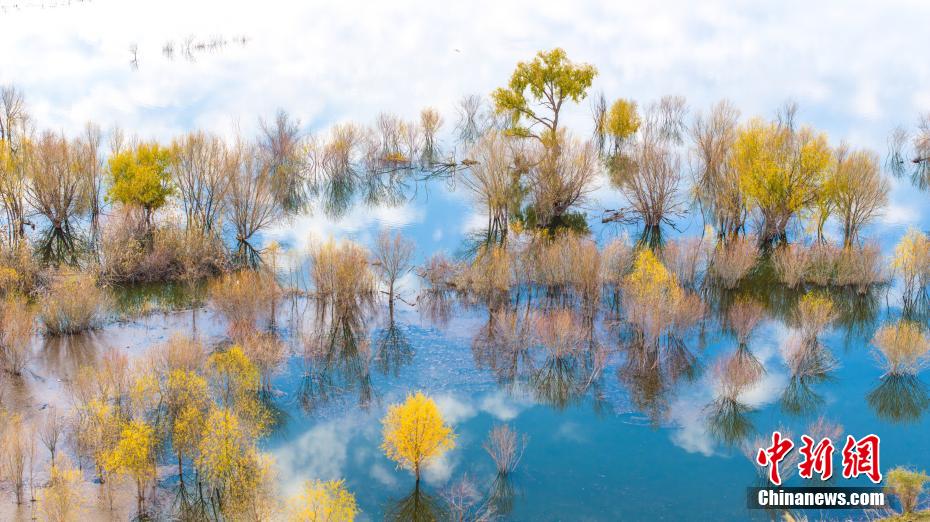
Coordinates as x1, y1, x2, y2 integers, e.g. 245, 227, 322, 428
4, 172, 930, 520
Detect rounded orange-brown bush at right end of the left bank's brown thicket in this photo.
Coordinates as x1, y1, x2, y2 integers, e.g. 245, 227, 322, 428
210, 270, 280, 339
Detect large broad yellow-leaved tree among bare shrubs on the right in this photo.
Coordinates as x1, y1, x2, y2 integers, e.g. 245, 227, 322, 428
730, 118, 832, 246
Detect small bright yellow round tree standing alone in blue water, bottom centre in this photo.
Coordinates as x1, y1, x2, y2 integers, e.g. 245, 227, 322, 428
381, 392, 455, 483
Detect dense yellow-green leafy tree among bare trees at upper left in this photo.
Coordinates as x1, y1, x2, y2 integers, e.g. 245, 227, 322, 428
107, 142, 173, 226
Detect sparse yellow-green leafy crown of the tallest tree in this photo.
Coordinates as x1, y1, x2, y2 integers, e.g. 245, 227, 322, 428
491, 48, 597, 145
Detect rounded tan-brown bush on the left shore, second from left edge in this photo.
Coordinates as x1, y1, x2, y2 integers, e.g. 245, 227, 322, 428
39, 271, 107, 335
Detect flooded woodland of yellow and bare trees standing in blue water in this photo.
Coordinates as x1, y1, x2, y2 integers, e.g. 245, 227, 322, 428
0, 2, 930, 521
